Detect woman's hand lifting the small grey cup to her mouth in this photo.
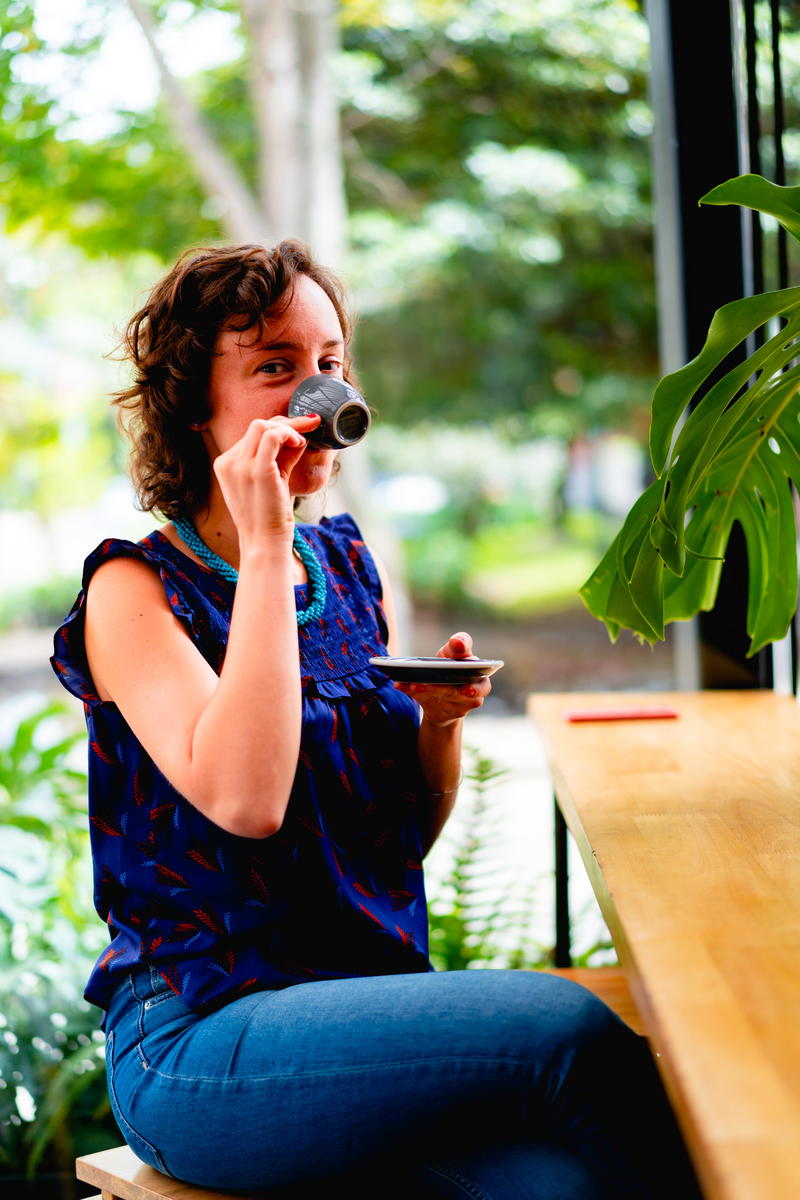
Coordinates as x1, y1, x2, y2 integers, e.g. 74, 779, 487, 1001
213, 413, 320, 546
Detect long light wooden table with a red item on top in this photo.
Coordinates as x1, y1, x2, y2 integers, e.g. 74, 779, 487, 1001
529, 691, 800, 1200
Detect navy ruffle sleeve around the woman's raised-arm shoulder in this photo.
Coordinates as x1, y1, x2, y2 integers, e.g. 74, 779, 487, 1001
50, 538, 219, 708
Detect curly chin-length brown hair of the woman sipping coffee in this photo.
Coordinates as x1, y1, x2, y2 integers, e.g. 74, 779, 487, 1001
114, 239, 353, 520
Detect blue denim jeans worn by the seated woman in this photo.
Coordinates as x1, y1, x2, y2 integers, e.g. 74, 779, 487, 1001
107, 967, 699, 1200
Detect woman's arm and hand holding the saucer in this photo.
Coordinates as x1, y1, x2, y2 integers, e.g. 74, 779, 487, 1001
373, 554, 492, 854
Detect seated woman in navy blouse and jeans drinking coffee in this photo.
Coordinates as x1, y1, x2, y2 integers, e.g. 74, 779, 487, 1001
53, 241, 693, 1200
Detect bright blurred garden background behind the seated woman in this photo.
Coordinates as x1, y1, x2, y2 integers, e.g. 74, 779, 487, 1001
6, 0, 800, 1198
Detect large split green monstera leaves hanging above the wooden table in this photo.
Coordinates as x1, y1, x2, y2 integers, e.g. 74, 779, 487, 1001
581, 175, 800, 654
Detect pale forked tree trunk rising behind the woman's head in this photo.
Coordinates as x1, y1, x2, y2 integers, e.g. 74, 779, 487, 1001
127, 0, 344, 263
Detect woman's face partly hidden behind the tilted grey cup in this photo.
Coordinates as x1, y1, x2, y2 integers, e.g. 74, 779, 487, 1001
203, 275, 344, 496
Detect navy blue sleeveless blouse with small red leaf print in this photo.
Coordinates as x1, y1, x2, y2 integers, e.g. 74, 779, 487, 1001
52, 515, 432, 1012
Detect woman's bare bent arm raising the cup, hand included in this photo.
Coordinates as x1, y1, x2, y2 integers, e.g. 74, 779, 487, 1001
86, 421, 314, 838
